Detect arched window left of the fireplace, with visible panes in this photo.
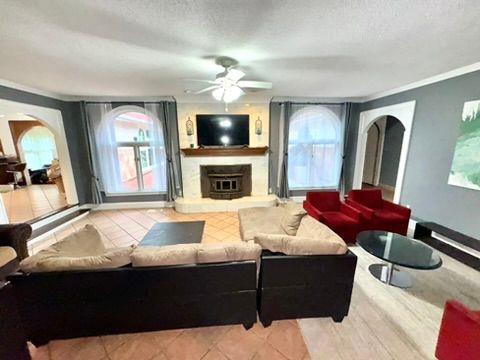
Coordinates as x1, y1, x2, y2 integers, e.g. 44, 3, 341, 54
96, 106, 166, 194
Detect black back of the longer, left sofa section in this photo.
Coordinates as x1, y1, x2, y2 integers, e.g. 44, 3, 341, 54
9, 261, 257, 346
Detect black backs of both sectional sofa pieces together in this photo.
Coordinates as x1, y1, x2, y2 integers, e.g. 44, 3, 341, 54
2, 222, 356, 352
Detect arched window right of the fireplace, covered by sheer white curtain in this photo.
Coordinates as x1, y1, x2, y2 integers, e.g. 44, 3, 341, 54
288, 106, 342, 190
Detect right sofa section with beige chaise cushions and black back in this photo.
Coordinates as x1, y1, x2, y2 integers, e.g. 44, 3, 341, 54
239, 205, 357, 326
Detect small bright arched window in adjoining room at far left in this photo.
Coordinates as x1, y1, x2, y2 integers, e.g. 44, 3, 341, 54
20, 126, 58, 170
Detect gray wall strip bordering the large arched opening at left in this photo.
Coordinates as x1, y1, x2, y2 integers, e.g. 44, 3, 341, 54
0, 86, 92, 204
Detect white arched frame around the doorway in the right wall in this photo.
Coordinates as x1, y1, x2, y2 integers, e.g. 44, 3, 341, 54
353, 101, 415, 203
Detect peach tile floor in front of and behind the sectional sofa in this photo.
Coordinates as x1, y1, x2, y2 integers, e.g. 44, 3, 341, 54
30, 209, 310, 360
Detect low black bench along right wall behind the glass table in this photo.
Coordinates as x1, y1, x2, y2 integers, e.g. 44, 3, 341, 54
413, 222, 480, 271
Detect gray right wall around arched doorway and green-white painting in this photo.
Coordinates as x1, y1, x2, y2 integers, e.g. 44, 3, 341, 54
346, 71, 480, 239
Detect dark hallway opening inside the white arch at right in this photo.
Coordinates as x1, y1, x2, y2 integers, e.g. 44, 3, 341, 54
362, 116, 405, 201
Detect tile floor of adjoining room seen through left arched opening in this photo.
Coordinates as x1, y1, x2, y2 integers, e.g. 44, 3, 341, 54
1, 184, 67, 223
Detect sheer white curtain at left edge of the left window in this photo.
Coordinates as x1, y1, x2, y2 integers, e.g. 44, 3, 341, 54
87, 103, 123, 193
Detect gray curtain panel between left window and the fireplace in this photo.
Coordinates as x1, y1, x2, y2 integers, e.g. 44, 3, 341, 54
159, 101, 183, 201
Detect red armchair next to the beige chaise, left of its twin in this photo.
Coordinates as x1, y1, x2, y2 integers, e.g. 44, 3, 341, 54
303, 191, 361, 244
